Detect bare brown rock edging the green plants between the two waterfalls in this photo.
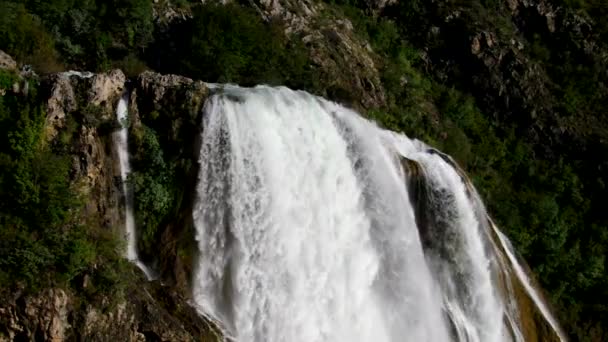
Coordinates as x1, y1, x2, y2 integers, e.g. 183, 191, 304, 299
130, 72, 210, 292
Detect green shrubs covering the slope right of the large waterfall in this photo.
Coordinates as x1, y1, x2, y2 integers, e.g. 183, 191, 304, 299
334, 1, 608, 341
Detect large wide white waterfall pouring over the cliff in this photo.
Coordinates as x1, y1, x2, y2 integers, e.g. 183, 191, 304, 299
193, 86, 563, 342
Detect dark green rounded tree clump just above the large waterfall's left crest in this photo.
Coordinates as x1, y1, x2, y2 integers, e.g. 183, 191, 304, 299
153, 2, 311, 88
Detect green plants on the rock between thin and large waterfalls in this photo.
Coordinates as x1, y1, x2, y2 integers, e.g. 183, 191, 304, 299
129, 86, 204, 262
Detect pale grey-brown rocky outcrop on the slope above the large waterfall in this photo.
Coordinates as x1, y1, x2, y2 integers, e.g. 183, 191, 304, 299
256, 0, 388, 109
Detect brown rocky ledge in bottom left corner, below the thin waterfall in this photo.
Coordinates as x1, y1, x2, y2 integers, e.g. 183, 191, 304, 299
0, 279, 220, 342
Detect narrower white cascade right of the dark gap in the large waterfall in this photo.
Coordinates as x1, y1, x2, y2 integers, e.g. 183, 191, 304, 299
405, 153, 506, 342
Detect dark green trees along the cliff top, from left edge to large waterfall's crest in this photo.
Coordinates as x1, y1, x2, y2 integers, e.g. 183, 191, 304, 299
0, 0, 311, 88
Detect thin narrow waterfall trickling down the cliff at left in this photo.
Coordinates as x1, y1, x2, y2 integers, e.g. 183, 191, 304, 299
114, 93, 155, 280
